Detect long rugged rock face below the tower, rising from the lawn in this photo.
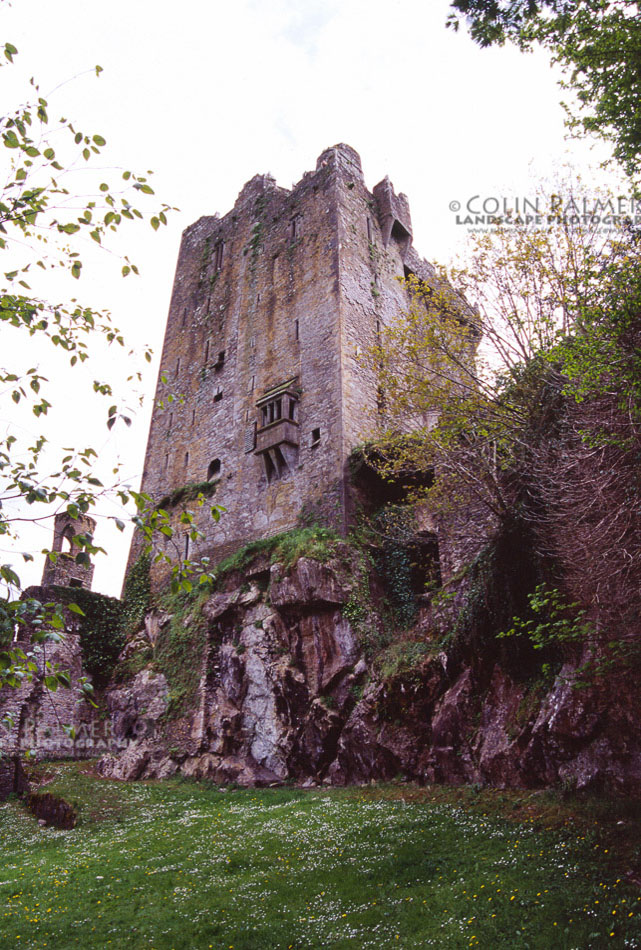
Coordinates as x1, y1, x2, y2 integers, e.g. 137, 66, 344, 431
95, 556, 641, 794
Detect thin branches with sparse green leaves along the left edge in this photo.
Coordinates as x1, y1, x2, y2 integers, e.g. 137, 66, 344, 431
0, 37, 218, 688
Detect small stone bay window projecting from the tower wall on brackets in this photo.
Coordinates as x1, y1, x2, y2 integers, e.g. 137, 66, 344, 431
254, 377, 300, 482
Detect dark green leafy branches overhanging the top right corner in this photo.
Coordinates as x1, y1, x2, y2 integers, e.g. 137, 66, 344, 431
448, 0, 641, 176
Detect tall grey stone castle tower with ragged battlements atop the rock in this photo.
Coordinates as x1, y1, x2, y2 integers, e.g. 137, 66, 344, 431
130, 145, 442, 584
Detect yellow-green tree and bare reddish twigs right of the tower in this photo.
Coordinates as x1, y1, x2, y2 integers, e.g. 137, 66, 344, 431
367, 193, 641, 618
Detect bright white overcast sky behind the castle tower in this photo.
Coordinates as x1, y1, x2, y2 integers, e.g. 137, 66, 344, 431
0, 0, 616, 594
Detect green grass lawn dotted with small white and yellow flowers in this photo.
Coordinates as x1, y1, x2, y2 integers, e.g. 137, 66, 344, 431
0, 763, 641, 950
